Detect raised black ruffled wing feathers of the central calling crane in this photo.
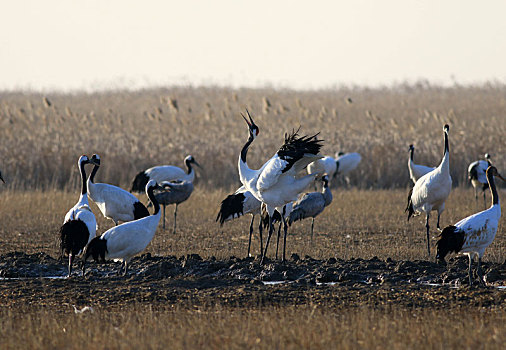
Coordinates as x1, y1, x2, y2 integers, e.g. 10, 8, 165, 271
277, 130, 323, 173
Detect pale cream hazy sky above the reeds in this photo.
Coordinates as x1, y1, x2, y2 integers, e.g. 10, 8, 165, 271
0, 0, 506, 90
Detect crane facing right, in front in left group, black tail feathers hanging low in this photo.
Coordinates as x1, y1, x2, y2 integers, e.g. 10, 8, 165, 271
83, 180, 160, 275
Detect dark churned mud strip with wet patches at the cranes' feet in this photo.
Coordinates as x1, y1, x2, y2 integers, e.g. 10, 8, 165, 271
0, 252, 506, 308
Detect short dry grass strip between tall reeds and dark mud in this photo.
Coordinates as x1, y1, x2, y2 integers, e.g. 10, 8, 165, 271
0, 188, 506, 262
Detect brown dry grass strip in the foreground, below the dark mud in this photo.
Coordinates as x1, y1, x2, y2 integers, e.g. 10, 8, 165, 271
0, 305, 506, 349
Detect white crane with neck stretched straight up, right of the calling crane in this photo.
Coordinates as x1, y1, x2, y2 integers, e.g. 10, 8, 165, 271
406, 124, 452, 256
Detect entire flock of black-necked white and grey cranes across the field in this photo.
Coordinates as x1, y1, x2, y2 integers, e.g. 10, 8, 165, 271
0, 110, 500, 285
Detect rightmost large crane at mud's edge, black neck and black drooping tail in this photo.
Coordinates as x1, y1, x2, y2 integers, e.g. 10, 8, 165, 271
437, 166, 506, 285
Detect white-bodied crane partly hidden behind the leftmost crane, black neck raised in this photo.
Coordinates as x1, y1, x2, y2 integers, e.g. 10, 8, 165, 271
87, 154, 149, 225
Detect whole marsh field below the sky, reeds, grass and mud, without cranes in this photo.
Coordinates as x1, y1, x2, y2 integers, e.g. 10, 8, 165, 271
0, 85, 506, 349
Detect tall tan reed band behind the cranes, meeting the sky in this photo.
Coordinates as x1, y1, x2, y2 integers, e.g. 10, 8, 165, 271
0, 84, 506, 189
